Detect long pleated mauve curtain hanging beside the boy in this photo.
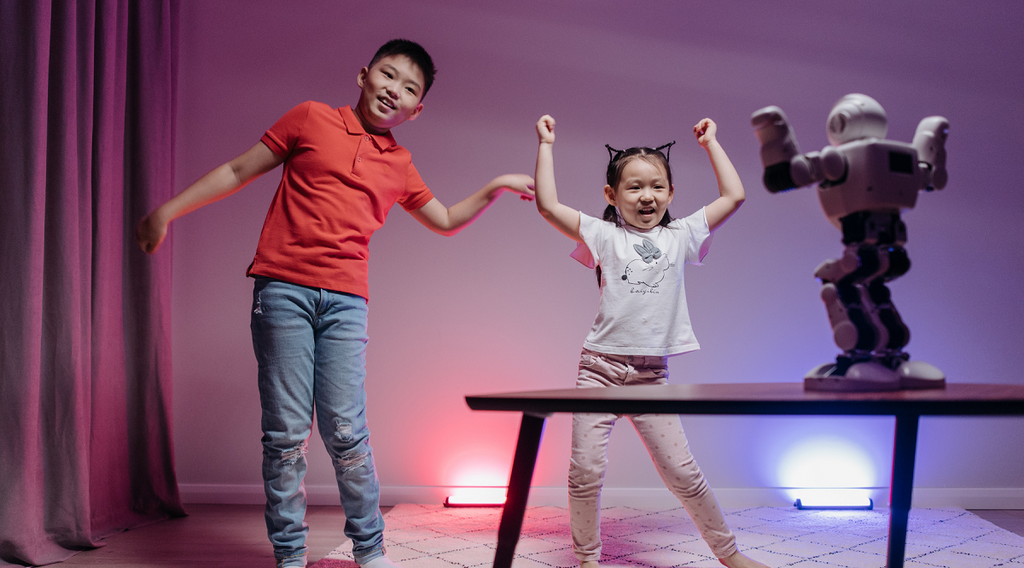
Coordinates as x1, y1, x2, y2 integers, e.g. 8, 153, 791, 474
0, 0, 183, 565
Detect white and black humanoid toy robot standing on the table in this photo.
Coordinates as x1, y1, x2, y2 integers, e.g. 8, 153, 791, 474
751, 94, 949, 391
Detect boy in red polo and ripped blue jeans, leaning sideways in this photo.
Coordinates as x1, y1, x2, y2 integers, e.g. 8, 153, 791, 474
135, 40, 534, 568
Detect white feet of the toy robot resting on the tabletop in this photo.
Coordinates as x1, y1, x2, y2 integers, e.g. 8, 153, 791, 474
804, 357, 946, 392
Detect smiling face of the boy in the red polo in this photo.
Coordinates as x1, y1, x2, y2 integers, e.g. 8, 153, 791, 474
353, 55, 425, 134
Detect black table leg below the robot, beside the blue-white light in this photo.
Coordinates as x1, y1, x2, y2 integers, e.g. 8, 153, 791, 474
886, 414, 921, 568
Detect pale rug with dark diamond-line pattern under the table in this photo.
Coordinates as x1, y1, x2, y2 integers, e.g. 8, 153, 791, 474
313, 505, 1024, 568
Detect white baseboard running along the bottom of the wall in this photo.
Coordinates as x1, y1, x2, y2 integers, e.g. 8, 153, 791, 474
178, 483, 1024, 510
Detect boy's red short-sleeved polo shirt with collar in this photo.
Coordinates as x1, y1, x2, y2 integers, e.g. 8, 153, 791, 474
253, 101, 433, 299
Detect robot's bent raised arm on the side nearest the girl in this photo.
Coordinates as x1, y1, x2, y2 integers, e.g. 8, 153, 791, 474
751, 106, 847, 193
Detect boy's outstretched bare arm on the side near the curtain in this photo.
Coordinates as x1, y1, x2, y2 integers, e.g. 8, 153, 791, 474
135, 142, 285, 255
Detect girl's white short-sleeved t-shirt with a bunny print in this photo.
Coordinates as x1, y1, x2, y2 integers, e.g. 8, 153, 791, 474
571, 208, 712, 356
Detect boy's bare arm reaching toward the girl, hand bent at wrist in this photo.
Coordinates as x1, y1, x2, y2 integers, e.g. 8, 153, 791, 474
410, 174, 534, 236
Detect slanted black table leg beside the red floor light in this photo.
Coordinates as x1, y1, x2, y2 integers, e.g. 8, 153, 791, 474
495, 412, 546, 568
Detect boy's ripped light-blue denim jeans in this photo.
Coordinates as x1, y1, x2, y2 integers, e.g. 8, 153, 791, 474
251, 277, 384, 566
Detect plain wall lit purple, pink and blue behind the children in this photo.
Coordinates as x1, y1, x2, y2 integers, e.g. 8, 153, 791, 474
173, 0, 1024, 507
